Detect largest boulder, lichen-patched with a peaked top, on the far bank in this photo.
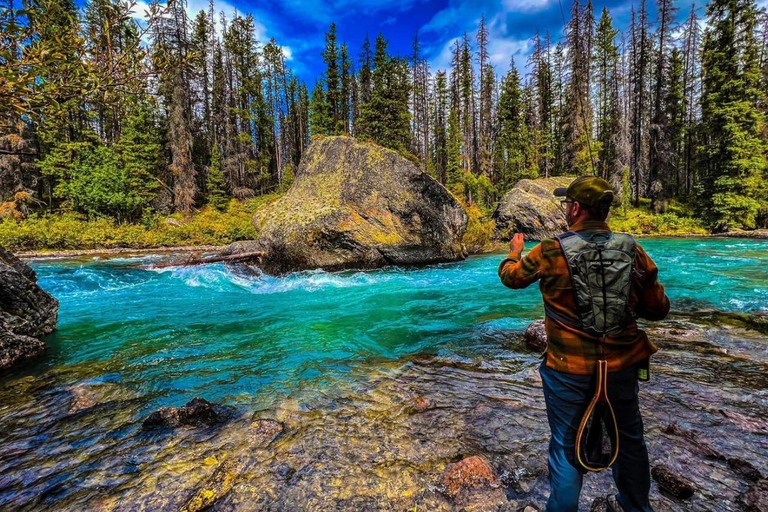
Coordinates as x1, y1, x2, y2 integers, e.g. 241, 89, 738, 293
228, 137, 467, 274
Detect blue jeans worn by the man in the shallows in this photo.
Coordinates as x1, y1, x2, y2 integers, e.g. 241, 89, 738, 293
540, 360, 653, 512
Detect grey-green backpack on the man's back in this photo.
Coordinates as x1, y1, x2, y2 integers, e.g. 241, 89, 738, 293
546, 231, 637, 337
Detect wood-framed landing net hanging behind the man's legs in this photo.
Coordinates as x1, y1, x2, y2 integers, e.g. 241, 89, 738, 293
576, 359, 619, 471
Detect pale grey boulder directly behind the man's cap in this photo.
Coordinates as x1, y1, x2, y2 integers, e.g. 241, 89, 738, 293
493, 177, 573, 240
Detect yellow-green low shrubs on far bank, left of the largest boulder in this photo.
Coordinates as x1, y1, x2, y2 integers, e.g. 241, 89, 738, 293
0, 194, 279, 251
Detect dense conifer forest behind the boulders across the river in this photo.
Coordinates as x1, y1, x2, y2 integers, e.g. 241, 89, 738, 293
0, 0, 768, 231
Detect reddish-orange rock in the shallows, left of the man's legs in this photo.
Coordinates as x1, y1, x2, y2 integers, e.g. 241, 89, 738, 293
441, 455, 504, 503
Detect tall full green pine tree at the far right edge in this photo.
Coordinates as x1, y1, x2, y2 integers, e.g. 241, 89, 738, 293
699, 0, 767, 230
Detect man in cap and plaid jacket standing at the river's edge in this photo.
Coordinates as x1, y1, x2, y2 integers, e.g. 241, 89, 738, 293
499, 176, 669, 512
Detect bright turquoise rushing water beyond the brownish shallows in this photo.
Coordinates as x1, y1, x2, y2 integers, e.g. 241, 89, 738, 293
27, 239, 768, 407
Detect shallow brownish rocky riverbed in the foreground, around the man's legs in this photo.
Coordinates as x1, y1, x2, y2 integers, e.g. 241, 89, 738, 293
0, 312, 768, 512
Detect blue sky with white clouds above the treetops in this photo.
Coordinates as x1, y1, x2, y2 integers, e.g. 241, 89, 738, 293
130, 0, 756, 87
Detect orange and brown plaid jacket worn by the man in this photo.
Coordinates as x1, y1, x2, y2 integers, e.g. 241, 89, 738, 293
499, 221, 669, 375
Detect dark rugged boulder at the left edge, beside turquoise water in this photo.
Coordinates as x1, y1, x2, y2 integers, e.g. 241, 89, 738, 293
0, 247, 59, 370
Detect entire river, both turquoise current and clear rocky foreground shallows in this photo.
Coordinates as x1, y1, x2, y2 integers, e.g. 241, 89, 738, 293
0, 238, 768, 511
